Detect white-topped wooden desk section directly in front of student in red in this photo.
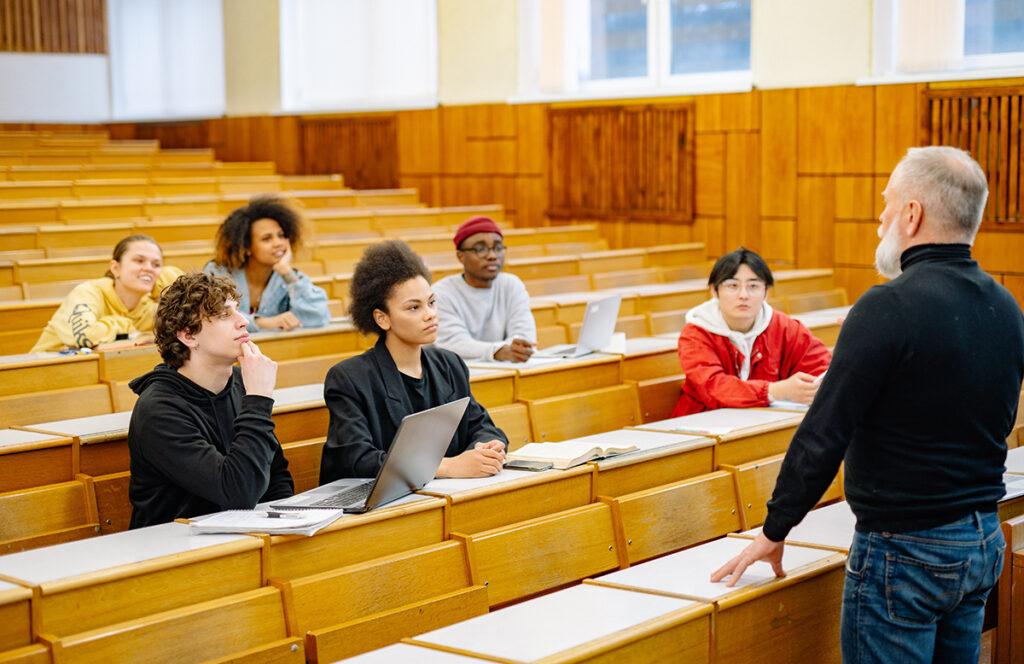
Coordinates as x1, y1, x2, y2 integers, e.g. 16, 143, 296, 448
635, 408, 804, 467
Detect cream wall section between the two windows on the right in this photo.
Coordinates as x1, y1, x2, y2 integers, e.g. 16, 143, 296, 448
751, 0, 871, 89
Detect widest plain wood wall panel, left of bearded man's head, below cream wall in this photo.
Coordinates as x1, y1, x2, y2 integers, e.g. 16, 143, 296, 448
797, 85, 874, 175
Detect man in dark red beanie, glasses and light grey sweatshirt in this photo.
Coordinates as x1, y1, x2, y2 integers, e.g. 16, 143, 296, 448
433, 216, 537, 362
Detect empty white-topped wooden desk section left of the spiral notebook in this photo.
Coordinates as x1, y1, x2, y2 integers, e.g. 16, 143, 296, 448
0, 523, 266, 636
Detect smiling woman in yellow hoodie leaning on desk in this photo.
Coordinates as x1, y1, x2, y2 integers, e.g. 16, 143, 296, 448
32, 235, 181, 352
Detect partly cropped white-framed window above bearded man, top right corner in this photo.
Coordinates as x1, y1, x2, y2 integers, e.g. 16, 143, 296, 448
872, 0, 1024, 80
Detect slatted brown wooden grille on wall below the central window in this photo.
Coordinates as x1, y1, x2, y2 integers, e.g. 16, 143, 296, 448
548, 105, 693, 222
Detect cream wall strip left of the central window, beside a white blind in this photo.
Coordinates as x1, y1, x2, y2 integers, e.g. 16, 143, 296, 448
437, 0, 519, 105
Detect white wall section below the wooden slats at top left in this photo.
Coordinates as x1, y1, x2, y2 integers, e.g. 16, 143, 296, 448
0, 53, 111, 123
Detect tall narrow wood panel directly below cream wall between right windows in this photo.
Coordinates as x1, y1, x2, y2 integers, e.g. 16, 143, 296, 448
761, 89, 797, 218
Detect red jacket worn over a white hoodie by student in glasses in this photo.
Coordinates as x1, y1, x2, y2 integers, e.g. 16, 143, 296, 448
672, 310, 831, 417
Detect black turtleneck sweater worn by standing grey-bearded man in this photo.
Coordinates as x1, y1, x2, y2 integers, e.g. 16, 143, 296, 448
764, 245, 1024, 541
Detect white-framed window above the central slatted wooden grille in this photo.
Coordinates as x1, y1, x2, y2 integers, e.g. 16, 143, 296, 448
519, 0, 751, 97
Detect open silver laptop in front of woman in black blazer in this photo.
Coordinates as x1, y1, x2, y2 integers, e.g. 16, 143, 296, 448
270, 397, 469, 513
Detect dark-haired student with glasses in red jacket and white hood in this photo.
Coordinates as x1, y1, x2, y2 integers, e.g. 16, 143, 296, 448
672, 247, 831, 417
